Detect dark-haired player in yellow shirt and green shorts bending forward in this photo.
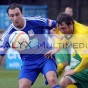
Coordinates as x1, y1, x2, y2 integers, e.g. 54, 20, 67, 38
57, 13, 88, 88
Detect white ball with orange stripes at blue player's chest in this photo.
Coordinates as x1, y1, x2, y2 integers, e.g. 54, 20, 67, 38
9, 31, 30, 51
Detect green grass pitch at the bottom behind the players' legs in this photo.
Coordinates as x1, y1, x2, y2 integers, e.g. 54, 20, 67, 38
0, 69, 59, 88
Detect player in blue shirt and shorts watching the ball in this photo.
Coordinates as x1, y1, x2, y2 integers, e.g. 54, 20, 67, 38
0, 3, 60, 88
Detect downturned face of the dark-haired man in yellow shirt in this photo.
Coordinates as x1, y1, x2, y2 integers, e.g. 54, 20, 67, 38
57, 22, 73, 34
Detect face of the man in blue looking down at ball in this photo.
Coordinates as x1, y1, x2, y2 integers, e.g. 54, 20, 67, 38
8, 8, 23, 28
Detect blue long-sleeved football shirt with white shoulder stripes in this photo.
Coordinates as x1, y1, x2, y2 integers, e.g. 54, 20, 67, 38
0, 17, 56, 60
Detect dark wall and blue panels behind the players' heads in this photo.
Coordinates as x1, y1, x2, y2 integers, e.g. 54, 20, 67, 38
0, 0, 88, 30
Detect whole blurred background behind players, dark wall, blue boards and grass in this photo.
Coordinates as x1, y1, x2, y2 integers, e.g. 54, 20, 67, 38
0, 0, 88, 88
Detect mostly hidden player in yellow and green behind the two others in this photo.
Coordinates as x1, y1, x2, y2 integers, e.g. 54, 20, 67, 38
51, 7, 73, 76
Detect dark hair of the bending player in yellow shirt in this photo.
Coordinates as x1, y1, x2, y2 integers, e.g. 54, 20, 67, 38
56, 12, 74, 25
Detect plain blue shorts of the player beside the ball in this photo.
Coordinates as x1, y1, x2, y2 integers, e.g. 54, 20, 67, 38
19, 58, 57, 84
